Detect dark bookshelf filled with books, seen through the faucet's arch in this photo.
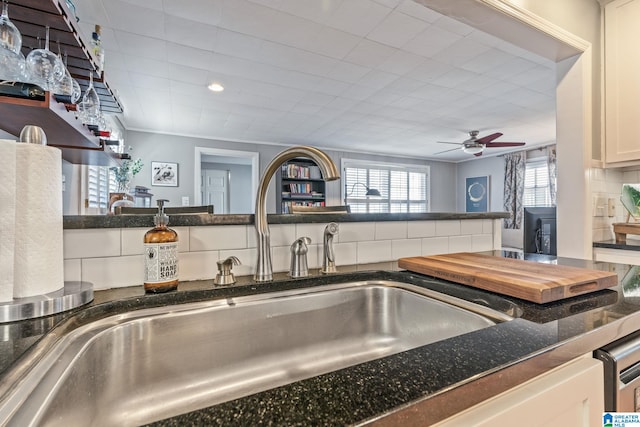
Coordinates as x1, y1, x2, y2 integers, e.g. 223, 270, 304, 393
276, 158, 326, 214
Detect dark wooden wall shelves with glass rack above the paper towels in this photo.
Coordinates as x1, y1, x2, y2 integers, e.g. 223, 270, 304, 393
0, 0, 122, 166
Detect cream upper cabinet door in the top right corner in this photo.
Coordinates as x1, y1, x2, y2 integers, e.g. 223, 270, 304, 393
604, 0, 640, 166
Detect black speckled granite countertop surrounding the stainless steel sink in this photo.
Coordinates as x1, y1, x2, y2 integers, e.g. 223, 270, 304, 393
0, 251, 640, 426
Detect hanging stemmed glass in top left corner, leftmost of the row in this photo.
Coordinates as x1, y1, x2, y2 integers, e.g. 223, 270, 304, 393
0, 0, 25, 80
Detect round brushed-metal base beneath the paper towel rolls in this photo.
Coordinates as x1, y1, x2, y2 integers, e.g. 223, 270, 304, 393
0, 282, 93, 323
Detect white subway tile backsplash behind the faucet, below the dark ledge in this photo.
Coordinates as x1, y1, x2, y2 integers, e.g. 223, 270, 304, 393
64, 220, 502, 289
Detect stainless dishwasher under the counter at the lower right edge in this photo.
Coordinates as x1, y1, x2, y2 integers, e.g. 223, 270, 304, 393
594, 331, 640, 412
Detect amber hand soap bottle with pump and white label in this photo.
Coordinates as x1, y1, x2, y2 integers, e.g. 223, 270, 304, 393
144, 199, 178, 293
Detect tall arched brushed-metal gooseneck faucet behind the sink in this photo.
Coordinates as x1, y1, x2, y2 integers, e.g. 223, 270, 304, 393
253, 146, 340, 282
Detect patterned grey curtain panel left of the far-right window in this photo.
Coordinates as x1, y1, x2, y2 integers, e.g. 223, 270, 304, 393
504, 152, 526, 230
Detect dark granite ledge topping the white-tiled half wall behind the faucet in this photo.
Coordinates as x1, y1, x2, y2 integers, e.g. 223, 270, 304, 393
62, 212, 509, 229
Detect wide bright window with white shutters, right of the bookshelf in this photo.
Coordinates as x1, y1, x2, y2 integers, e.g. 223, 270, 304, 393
342, 159, 430, 213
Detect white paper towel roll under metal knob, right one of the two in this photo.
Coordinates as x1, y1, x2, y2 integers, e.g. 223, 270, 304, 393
13, 144, 64, 298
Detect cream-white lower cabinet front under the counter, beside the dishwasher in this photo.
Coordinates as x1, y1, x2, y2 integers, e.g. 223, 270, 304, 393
435, 354, 604, 427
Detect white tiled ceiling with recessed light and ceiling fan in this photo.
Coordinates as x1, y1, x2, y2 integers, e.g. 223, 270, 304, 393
76, 0, 555, 161
